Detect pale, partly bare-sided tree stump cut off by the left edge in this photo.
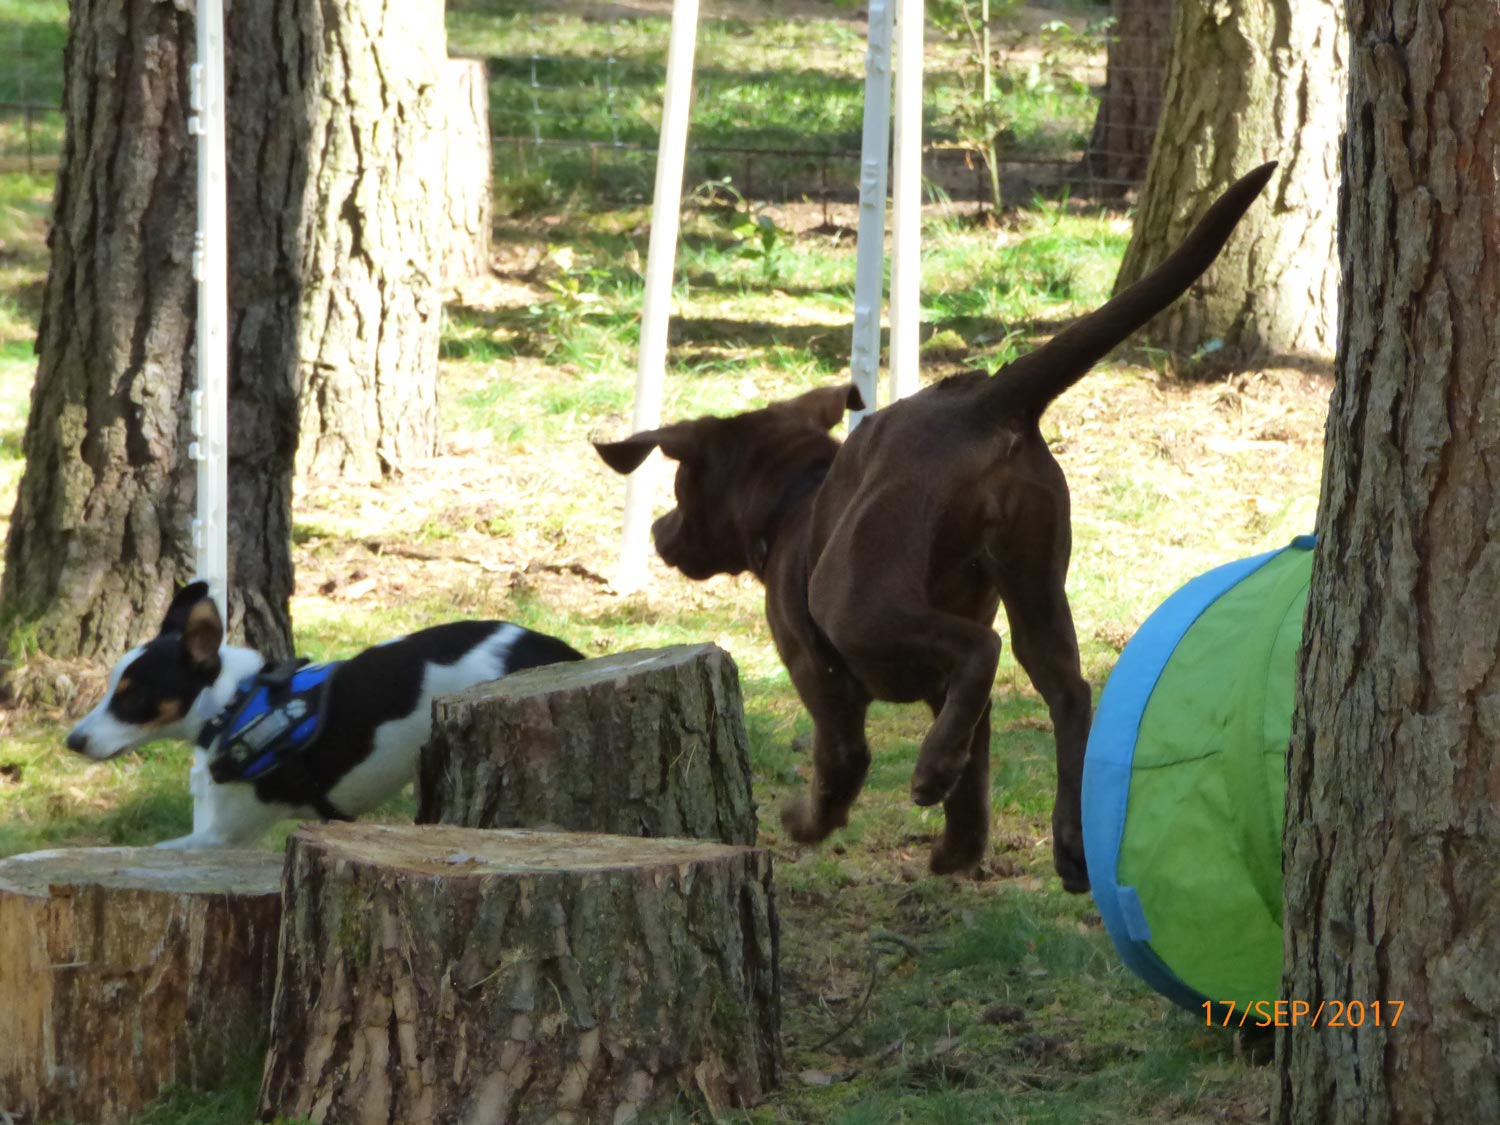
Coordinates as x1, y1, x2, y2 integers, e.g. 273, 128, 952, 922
0, 848, 282, 1125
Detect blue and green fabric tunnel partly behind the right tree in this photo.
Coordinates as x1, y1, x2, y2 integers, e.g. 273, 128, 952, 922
1083, 536, 1313, 1011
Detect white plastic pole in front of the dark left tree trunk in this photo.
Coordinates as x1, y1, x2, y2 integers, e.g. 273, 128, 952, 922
188, 0, 230, 621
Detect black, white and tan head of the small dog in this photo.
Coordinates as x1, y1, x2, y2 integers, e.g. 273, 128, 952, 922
68, 582, 237, 761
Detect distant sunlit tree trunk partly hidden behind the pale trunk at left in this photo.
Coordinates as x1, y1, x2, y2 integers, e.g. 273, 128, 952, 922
443, 59, 494, 290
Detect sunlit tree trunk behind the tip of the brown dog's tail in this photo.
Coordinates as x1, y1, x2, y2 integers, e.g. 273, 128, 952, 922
1116, 0, 1347, 362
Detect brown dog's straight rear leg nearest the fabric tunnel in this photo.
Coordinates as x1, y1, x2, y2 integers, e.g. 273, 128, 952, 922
1005, 579, 1094, 894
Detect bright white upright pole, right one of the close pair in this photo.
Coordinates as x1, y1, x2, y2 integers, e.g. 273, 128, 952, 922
891, 0, 926, 402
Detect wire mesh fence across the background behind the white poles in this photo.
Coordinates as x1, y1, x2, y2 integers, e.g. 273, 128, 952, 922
0, 0, 1173, 200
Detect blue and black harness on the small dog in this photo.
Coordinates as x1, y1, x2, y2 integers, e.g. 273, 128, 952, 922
198, 659, 350, 821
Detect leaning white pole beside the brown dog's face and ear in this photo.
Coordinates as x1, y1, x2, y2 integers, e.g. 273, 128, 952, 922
612, 0, 698, 594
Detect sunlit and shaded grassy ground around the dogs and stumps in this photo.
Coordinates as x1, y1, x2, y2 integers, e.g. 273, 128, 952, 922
0, 0, 1329, 1125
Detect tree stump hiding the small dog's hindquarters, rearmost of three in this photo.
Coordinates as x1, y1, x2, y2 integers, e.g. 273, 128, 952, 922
417, 645, 756, 845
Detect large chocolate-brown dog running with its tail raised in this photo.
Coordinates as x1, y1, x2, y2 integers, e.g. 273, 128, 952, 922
596, 164, 1275, 891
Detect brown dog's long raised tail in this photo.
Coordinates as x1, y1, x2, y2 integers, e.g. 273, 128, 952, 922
984, 161, 1277, 423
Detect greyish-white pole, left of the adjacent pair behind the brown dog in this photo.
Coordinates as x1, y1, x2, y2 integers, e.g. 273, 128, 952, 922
849, 0, 896, 429
